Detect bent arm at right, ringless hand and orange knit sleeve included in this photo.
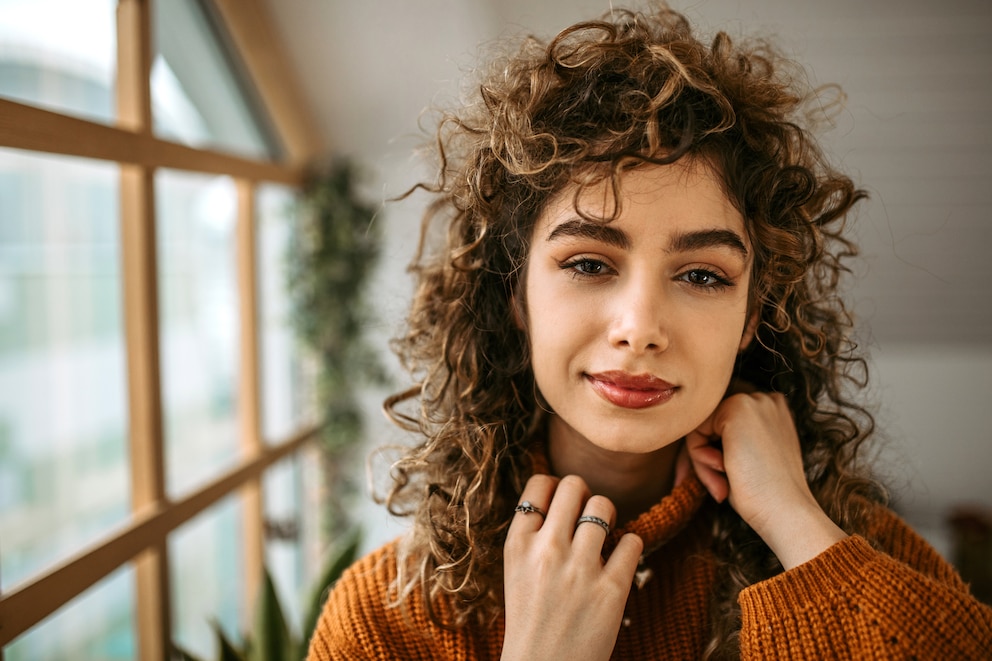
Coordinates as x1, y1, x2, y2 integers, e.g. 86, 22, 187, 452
687, 393, 992, 659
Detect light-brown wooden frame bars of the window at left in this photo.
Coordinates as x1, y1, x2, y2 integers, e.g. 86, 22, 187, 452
0, 0, 322, 661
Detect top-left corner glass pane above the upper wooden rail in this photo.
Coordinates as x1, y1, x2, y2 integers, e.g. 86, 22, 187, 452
0, 0, 117, 123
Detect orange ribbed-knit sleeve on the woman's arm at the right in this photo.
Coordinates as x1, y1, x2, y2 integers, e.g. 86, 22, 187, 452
739, 510, 992, 661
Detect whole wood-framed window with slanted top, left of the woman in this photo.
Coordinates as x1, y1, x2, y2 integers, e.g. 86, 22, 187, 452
0, 0, 320, 661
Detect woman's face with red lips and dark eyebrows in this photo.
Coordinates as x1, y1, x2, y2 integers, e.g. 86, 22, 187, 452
522, 164, 751, 453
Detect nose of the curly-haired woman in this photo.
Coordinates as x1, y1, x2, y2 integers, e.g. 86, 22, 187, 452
609, 281, 669, 354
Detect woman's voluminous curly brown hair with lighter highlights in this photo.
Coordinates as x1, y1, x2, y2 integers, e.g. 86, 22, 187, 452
385, 6, 882, 658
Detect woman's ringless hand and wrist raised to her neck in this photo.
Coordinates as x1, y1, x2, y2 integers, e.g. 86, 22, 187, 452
686, 392, 846, 569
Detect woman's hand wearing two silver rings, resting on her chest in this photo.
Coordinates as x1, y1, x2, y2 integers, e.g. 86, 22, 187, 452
502, 475, 644, 661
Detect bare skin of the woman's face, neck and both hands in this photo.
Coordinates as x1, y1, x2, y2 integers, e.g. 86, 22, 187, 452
503, 163, 844, 659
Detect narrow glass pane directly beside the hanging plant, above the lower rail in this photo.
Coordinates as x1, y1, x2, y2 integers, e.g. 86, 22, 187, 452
256, 185, 315, 444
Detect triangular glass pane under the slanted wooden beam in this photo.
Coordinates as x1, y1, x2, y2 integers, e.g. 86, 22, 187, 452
151, 0, 275, 159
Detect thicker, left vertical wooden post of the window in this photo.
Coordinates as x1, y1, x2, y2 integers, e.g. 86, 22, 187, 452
117, 0, 172, 661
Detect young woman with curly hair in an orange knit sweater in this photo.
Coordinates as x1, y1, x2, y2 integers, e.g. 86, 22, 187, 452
310, 8, 992, 660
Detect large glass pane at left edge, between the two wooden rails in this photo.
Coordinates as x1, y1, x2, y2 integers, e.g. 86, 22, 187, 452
0, 149, 130, 589
